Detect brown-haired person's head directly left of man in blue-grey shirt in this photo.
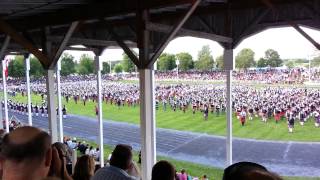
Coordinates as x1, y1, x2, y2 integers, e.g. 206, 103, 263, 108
72, 155, 95, 180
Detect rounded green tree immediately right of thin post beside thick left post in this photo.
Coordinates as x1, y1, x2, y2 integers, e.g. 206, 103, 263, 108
61, 53, 76, 76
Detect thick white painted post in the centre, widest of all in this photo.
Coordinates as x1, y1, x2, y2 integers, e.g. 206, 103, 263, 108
139, 68, 156, 179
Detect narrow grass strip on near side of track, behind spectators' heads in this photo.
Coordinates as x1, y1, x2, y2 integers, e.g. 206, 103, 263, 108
82, 139, 320, 180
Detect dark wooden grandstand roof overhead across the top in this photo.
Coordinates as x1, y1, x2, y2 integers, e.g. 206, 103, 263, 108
0, 0, 320, 67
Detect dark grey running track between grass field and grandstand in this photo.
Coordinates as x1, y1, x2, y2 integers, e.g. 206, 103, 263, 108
9, 112, 320, 177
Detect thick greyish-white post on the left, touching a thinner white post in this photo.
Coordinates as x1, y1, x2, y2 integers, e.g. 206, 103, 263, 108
46, 69, 58, 143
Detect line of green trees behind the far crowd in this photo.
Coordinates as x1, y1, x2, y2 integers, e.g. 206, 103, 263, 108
8, 45, 320, 77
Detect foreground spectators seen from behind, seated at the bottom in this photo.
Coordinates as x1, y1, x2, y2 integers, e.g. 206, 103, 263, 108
0, 126, 281, 180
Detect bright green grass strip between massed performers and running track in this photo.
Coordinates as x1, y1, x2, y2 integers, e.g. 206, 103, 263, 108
9, 95, 320, 142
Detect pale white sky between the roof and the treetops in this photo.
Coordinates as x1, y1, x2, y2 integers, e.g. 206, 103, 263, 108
66, 27, 320, 61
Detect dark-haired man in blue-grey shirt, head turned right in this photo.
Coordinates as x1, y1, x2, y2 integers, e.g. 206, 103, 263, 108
92, 144, 139, 180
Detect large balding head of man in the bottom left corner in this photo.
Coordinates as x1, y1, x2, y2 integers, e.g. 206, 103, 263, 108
1, 126, 52, 180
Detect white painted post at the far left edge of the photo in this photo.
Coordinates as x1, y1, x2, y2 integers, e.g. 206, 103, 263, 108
1, 60, 9, 133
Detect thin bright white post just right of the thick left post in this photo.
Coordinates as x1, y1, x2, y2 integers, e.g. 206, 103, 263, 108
56, 59, 63, 143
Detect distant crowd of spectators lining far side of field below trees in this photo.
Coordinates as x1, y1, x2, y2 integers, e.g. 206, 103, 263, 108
7, 68, 320, 85
